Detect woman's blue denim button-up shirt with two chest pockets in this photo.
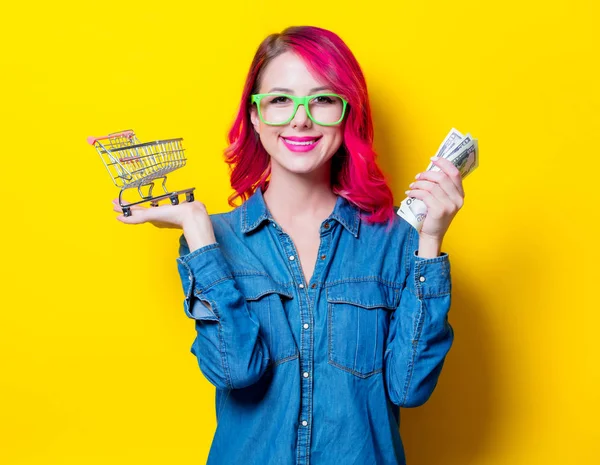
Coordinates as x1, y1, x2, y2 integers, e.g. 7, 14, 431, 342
177, 189, 453, 465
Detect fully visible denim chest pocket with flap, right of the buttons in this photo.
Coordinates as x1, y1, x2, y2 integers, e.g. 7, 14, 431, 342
326, 281, 400, 378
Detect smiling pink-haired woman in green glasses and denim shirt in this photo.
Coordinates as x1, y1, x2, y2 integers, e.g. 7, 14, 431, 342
115, 27, 464, 465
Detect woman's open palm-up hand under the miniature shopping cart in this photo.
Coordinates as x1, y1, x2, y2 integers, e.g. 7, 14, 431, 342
112, 199, 216, 252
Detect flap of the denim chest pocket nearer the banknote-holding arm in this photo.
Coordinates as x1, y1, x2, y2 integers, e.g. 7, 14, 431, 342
326, 281, 400, 309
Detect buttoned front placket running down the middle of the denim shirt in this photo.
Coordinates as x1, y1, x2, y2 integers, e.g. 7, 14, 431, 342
271, 219, 335, 465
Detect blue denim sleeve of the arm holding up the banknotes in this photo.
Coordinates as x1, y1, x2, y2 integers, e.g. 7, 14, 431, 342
384, 227, 454, 407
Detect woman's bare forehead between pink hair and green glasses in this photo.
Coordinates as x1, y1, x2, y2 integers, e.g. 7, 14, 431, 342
259, 52, 329, 95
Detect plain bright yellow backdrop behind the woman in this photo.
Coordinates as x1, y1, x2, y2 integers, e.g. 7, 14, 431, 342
0, 0, 600, 465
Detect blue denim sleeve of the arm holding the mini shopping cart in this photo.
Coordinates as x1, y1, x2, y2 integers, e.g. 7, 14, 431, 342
177, 234, 269, 389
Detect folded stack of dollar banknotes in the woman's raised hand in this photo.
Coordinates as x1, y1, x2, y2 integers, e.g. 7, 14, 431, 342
397, 128, 479, 232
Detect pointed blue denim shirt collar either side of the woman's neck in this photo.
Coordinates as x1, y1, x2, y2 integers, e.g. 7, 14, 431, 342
241, 187, 360, 237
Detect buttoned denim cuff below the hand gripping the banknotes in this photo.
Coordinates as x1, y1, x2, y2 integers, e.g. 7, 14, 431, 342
408, 250, 452, 298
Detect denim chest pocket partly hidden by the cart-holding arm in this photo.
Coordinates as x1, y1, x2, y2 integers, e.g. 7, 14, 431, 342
234, 274, 299, 365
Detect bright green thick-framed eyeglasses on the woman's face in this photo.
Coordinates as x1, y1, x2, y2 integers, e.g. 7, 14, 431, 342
252, 94, 348, 126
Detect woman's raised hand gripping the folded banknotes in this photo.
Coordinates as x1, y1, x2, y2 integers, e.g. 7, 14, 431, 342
406, 158, 465, 244
